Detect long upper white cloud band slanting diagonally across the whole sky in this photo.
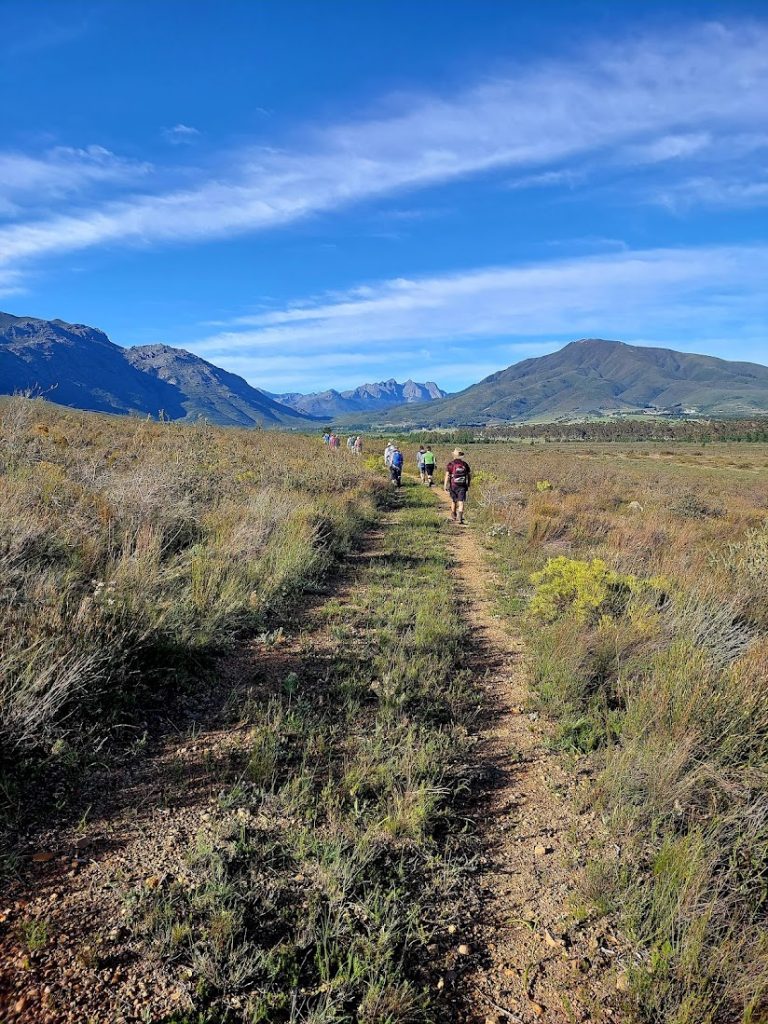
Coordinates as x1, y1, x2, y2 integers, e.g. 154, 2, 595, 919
0, 24, 768, 278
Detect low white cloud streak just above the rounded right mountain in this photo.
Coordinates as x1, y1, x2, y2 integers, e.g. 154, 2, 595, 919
190, 246, 768, 383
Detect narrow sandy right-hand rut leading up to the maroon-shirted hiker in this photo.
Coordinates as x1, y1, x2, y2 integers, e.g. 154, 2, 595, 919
436, 489, 621, 1024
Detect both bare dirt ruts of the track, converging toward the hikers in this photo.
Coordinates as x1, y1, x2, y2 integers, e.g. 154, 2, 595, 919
0, 481, 618, 1024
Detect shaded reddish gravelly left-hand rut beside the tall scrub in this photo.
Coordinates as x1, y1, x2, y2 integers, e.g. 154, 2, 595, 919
0, 540, 381, 1024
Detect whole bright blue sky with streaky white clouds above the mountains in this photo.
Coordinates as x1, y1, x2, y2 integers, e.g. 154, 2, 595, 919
0, 0, 768, 390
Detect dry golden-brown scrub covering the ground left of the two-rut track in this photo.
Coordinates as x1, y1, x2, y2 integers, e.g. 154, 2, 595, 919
0, 396, 381, 851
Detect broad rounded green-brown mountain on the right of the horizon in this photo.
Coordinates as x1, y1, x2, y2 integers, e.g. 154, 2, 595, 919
342, 338, 768, 427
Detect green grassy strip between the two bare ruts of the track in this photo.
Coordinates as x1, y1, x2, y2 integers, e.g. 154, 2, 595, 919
128, 486, 476, 1024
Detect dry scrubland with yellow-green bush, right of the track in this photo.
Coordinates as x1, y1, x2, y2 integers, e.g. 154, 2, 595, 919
440, 443, 768, 1024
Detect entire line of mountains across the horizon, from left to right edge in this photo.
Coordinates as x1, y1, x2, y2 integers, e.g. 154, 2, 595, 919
0, 312, 768, 429
